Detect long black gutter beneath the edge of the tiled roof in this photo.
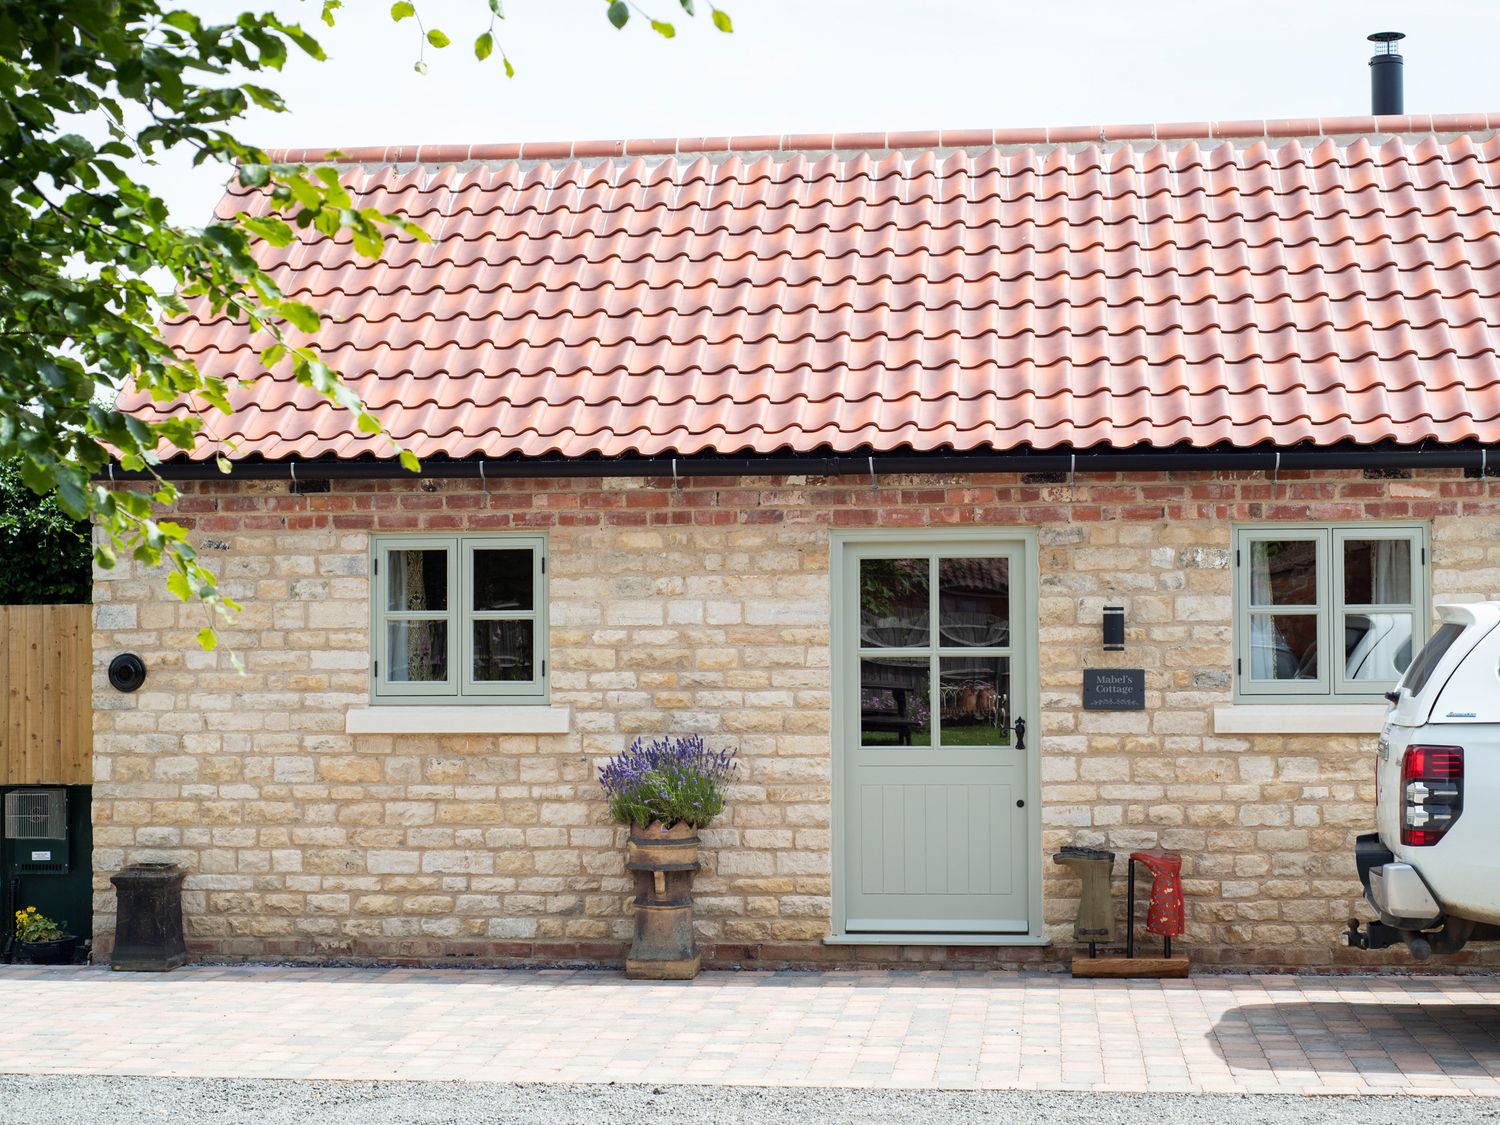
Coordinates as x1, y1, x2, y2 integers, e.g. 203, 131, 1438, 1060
108, 446, 1500, 480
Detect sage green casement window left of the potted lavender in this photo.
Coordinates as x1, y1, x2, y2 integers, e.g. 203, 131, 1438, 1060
371, 536, 548, 704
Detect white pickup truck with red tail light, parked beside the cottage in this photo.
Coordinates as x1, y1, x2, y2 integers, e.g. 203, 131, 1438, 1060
1346, 602, 1500, 960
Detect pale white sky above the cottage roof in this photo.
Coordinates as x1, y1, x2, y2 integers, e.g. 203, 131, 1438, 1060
152, 0, 1500, 224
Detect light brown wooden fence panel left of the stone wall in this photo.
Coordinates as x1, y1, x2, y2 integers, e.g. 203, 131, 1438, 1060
0, 606, 93, 785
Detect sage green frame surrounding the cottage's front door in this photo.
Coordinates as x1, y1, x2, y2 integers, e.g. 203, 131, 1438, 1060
824, 527, 1047, 947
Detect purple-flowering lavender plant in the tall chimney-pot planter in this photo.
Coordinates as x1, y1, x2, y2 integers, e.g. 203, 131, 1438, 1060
599, 735, 738, 828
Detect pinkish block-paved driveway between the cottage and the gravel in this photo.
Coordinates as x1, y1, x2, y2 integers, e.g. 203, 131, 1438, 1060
0, 966, 1500, 1097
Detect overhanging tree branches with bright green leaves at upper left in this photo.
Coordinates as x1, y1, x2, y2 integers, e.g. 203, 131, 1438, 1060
0, 0, 729, 644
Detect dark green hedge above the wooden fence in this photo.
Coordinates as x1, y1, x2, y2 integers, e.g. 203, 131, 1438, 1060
0, 462, 93, 606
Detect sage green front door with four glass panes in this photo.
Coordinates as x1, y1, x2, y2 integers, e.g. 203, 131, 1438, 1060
836, 540, 1035, 935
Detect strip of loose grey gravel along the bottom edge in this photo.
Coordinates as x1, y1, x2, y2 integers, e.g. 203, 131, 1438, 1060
0, 1076, 1500, 1125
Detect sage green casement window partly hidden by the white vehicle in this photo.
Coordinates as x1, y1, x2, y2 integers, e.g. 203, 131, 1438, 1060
1235, 524, 1430, 702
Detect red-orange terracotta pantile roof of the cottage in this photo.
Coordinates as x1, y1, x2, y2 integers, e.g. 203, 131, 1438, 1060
122, 114, 1500, 459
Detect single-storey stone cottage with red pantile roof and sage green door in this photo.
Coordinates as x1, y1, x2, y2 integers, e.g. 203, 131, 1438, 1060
93, 116, 1500, 968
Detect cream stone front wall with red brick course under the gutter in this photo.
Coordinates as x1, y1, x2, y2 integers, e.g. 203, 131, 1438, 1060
95, 471, 1500, 968
